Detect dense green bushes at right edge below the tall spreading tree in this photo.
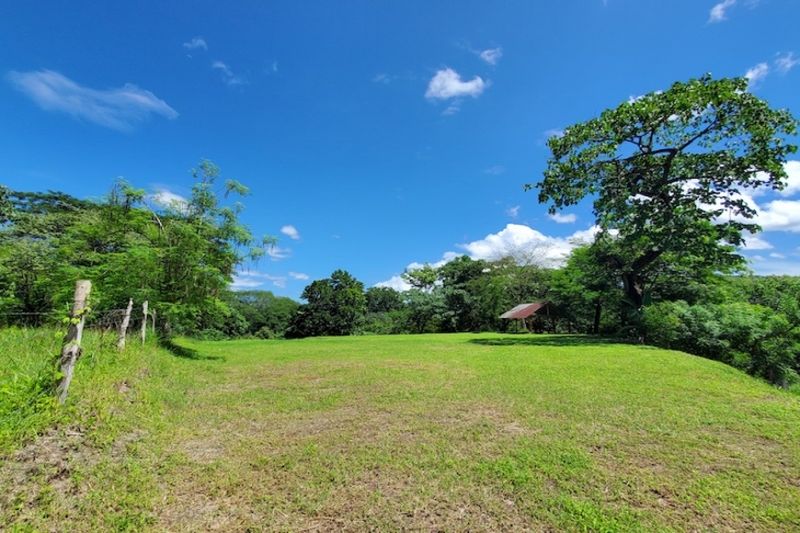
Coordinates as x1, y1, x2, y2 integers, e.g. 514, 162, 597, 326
643, 301, 800, 387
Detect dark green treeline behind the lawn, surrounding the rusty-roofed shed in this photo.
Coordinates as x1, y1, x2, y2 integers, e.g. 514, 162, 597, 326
285, 260, 800, 386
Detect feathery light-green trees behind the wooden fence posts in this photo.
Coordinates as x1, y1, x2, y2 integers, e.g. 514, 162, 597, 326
0, 161, 270, 334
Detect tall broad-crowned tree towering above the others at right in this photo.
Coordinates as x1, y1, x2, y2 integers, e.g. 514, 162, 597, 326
526, 76, 797, 310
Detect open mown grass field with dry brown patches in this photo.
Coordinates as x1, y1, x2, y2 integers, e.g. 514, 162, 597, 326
0, 334, 800, 531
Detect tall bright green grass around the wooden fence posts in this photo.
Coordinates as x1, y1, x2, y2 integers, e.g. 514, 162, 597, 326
0, 327, 155, 454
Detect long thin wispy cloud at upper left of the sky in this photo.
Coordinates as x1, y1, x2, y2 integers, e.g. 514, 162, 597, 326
7, 70, 178, 131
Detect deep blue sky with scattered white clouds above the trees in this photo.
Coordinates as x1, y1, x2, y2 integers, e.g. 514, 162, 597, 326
0, 0, 800, 297
